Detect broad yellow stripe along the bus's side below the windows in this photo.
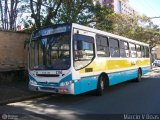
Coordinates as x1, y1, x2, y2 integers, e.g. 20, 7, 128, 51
80, 58, 150, 74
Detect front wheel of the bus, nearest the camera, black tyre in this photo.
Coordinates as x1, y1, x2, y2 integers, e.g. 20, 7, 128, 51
95, 75, 106, 96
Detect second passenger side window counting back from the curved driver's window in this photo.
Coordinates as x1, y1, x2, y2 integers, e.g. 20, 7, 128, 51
109, 38, 120, 57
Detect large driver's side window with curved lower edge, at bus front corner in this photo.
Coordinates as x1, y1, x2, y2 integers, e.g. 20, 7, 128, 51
74, 34, 95, 70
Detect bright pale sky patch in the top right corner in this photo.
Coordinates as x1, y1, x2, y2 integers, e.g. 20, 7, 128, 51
129, 0, 160, 27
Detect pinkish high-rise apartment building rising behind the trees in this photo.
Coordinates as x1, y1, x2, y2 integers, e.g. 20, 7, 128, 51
96, 0, 135, 16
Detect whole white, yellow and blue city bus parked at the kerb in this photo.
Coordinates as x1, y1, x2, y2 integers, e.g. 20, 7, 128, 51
28, 23, 151, 96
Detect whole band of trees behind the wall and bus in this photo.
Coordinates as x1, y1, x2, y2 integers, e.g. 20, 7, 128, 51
0, 0, 160, 47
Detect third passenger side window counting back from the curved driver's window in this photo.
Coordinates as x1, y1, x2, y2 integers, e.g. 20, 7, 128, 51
119, 40, 129, 57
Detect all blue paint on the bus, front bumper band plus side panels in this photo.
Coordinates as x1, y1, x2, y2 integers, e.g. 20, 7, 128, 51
29, 67, 150, 95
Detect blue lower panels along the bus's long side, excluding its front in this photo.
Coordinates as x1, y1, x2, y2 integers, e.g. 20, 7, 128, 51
74, 67, 150, 94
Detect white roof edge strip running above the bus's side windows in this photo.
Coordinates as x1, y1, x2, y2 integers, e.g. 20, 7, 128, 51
72, 23, 149, 46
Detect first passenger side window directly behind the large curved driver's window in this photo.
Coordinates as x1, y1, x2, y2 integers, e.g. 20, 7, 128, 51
96, 35, 110, 57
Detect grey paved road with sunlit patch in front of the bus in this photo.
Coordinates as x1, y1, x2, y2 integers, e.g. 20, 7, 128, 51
0, 71, 160, 120
